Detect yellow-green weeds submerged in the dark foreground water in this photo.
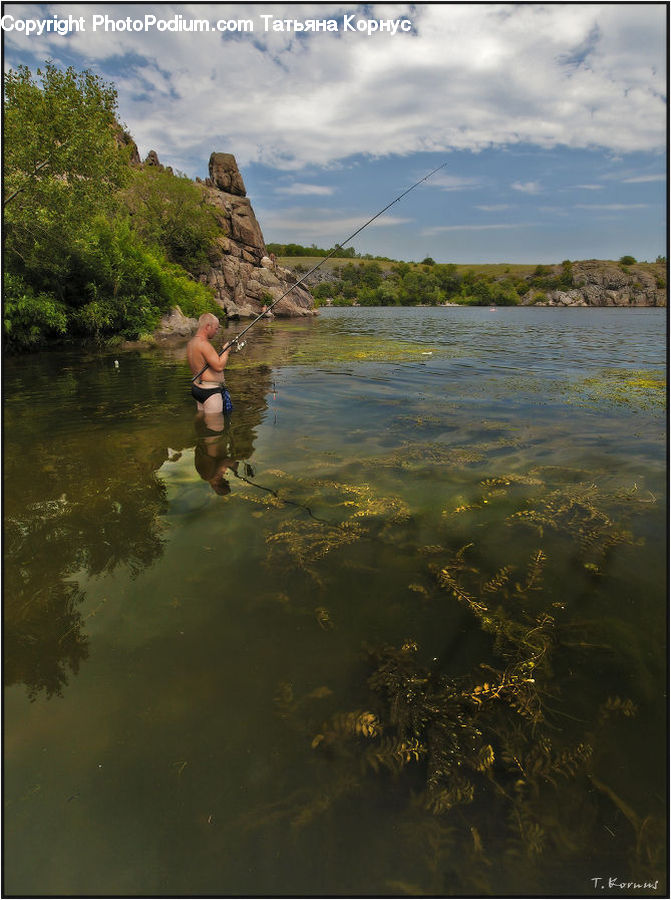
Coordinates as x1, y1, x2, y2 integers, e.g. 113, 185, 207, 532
227, 450, 664, 895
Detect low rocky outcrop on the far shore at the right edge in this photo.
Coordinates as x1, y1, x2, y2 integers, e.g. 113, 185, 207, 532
522, 259, 667, 306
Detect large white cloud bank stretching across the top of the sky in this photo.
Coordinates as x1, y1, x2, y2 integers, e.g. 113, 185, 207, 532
5, 3, 666, 171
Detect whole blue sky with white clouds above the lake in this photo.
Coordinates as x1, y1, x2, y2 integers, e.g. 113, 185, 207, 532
4, 3, 666, 262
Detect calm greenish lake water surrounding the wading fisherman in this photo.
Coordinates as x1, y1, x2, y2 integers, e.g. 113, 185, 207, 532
4, 308, 666, 896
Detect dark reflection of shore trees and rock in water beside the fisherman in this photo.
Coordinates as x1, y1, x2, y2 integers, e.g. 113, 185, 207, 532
4, 342, 270, 700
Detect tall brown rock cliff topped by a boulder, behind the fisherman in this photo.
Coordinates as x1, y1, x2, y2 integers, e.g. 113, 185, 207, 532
197, 153, 315, 316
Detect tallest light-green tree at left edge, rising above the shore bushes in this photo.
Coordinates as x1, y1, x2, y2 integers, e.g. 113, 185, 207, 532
3, 62, 129, 300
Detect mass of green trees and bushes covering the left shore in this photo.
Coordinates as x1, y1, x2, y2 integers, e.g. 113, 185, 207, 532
3, 63, 221, 351
